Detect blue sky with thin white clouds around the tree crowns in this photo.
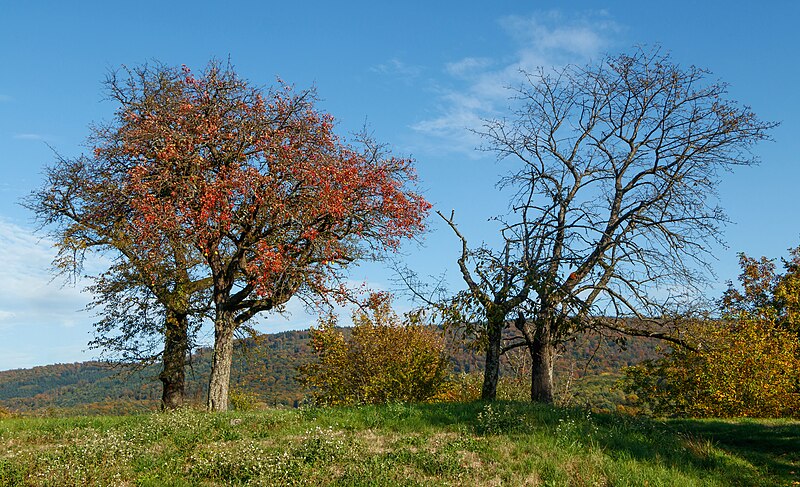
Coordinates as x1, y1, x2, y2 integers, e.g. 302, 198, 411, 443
0, 0, 800, 370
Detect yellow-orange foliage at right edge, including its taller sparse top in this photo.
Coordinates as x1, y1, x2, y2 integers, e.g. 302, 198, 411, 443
625, 249, 800, 417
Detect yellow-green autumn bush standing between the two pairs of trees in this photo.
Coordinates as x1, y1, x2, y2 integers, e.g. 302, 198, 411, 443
301, 299, 448, 405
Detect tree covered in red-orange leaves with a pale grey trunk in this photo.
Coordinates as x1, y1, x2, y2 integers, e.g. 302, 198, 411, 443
101, 63, 430, 411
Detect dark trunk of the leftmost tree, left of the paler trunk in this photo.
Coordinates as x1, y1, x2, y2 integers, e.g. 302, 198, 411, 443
158, 310, 189, 410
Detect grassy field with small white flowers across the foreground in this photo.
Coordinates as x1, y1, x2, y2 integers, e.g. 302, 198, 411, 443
0, 402, 800, 486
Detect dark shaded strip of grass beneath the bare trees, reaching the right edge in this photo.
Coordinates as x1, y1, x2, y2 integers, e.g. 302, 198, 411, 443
296, 401, 800, 486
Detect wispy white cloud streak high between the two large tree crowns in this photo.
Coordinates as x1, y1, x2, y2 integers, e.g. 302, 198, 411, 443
412, 12, 619, 157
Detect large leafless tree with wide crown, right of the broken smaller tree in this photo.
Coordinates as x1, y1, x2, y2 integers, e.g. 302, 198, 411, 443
472, 48, 776, 402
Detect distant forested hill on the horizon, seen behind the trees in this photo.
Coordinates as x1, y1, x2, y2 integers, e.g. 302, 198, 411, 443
0, 330, 658, 414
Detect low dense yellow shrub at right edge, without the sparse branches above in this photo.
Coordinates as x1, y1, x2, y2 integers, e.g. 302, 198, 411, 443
624, 320, 800, 417
